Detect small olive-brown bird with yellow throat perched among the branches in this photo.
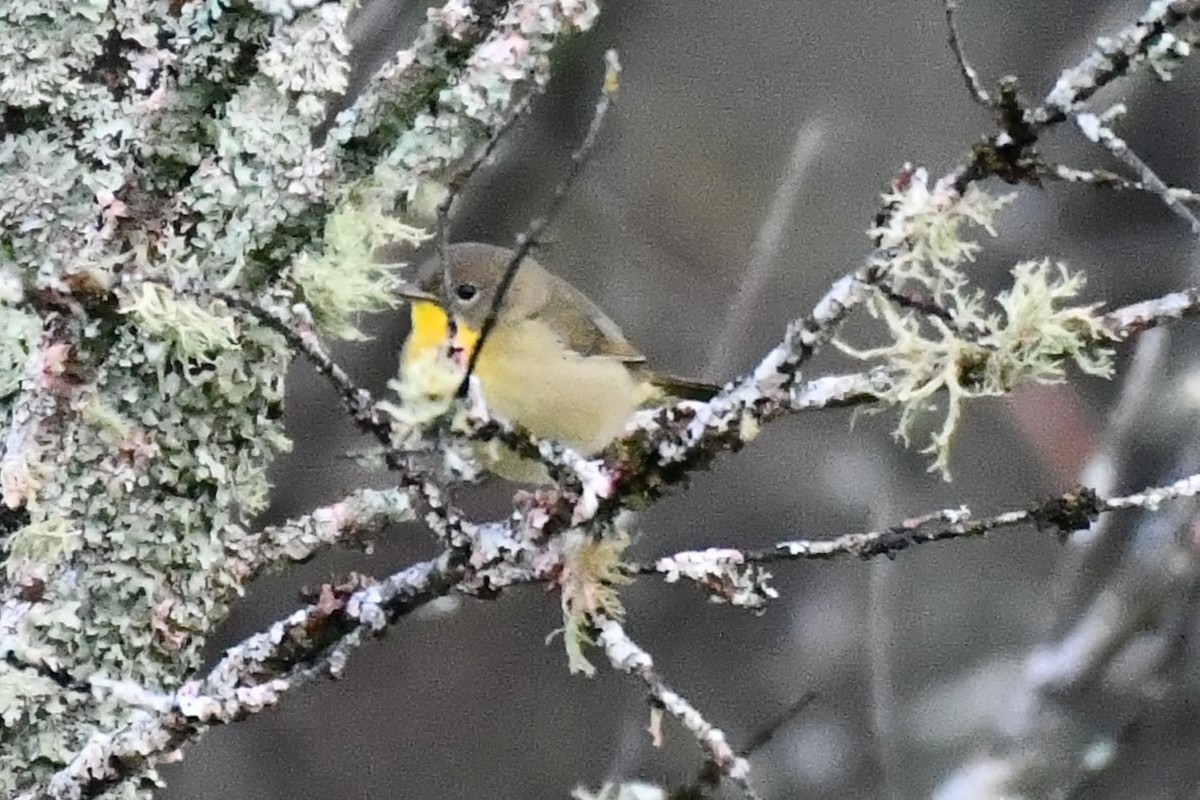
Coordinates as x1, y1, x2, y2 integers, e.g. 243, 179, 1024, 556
401, 242, 718, 483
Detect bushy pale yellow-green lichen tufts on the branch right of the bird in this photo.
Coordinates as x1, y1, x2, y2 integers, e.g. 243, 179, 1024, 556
836, 169, 1112, 479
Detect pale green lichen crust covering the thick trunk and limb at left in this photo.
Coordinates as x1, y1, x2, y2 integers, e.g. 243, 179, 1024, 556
0, 0, 600, 798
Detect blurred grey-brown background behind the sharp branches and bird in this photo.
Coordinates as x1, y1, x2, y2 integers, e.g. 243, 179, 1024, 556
163, 0, 1200, 800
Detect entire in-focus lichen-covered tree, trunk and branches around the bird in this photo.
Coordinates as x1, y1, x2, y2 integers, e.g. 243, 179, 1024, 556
7, 0, 1200, 800
